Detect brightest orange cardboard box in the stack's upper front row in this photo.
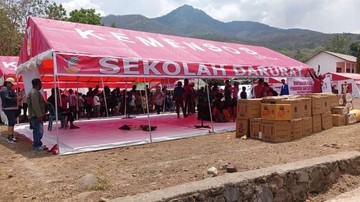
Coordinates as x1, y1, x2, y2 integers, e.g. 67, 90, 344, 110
261, 104, 293, 120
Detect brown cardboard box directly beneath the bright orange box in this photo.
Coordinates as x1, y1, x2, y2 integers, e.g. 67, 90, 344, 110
262, 120, 291, 142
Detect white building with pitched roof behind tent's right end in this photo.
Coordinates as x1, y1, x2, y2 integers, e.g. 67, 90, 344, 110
306, 51, 360, 74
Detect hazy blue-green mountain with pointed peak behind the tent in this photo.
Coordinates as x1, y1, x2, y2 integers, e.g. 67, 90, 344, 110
102, 5, 359, 61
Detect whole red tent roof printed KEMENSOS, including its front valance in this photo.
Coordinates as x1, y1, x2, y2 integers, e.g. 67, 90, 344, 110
16, 17, 313, 80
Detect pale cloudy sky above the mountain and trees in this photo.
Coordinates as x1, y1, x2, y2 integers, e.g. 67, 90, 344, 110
53, 0, 360, 33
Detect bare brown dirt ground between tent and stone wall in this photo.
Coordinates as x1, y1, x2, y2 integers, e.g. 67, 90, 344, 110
0, 99, 360, 201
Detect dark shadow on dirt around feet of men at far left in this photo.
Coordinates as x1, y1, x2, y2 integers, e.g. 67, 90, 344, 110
0, 128, 53, 159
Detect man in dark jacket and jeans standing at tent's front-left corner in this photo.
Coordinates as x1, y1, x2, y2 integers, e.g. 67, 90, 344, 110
27, 78, 47, 151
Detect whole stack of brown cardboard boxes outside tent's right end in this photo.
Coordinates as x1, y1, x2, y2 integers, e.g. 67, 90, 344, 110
236, 94, 356, 142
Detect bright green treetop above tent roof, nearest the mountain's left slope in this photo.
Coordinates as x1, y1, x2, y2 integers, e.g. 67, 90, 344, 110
67, 8, 101, 25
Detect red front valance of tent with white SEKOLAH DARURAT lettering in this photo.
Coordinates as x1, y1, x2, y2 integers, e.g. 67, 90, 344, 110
57, 54, 308, 78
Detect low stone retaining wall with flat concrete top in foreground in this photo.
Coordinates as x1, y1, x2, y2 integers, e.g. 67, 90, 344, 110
112, 152, 360, 202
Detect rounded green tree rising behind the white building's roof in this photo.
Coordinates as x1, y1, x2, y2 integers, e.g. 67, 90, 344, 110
325, 34, 351, 54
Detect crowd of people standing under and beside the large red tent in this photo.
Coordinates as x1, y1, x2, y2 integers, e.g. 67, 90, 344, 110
0, 78, 296, 150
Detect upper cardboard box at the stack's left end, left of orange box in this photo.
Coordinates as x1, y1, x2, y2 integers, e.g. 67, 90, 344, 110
237, 99, 261, 119
